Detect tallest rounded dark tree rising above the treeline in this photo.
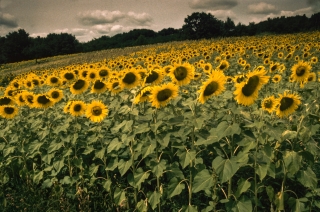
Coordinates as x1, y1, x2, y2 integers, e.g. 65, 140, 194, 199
182, 12, 223, 39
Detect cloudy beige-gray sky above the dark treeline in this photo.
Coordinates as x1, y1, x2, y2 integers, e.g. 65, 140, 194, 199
0, 0, 320, 42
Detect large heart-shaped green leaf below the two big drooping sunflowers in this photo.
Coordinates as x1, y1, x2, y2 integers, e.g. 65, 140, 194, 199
212, 156, 239, 183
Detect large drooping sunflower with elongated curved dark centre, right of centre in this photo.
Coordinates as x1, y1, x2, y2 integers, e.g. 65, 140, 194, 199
234, 69, 270, 106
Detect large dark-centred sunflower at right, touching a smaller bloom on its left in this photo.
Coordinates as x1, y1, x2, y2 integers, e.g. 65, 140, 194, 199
276, 91, 301, 118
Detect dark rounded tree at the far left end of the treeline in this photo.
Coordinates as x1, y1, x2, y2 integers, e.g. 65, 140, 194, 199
2, 29, 30, 63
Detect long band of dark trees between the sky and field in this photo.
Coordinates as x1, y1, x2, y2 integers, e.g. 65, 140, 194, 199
0, 12, 320, 64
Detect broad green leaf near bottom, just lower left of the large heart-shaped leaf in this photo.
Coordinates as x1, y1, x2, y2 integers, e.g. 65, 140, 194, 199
192, 169, 214, 193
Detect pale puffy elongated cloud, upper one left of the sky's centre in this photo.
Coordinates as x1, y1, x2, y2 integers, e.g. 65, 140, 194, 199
78, 10, 125, 26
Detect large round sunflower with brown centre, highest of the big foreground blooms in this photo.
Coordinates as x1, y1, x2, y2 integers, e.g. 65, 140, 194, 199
168, 63, 195, 85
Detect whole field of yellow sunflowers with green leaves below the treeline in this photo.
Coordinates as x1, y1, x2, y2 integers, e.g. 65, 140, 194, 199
0, 32, 320, 212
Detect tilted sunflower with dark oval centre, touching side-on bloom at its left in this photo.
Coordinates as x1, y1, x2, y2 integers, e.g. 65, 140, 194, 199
150, 83, 179, 108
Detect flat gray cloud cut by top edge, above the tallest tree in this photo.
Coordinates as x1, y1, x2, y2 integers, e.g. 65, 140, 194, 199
189, 0, 238, 10
